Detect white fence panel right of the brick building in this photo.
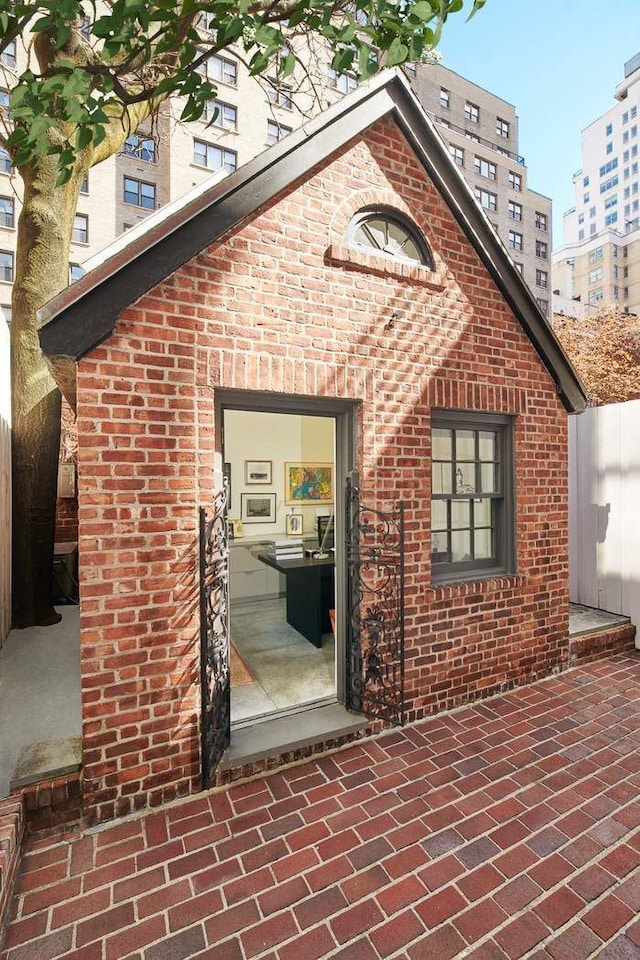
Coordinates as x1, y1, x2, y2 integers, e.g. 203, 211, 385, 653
569, 400, 640, 631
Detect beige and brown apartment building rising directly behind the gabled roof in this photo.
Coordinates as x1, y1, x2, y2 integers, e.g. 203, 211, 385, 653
0, 34, 551, 318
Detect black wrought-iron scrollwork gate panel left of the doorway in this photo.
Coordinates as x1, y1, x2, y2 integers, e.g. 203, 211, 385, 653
200, 485, 231, 789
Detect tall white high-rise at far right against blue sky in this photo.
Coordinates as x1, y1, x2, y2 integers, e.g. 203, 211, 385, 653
553, 53, 640, 313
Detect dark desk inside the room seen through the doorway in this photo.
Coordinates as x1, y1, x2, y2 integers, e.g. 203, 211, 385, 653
258, 553, 335, 647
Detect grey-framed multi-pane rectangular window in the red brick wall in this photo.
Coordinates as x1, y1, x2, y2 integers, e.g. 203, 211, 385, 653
431, 410, 514, 580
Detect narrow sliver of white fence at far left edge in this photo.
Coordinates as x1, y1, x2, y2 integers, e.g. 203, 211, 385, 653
0, 313, 11, 647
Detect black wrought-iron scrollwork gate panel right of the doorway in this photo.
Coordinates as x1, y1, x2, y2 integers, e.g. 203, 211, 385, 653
346, 474, 404, 725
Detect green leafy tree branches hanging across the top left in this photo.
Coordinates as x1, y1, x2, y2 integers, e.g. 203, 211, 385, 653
0, 0, 486, 181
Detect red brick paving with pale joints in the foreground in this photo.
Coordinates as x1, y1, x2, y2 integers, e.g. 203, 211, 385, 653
1, 655, 640, 960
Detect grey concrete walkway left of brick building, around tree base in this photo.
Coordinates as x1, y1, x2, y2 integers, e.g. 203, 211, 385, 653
0, 606, 82, 797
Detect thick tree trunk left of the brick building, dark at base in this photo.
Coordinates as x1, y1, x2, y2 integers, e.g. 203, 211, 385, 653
11, 157, 86, 628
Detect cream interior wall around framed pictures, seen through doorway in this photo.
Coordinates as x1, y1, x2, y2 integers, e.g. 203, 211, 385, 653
224, 410, 335, 538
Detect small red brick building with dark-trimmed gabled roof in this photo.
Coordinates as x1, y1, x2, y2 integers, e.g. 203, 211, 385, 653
41, 73, 584, 821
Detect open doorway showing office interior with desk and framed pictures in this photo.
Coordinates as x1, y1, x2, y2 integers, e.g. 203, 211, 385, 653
223, 407, 344, 727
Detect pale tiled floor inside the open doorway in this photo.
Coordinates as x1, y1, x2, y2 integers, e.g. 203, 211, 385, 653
230, 597, 336, 723
